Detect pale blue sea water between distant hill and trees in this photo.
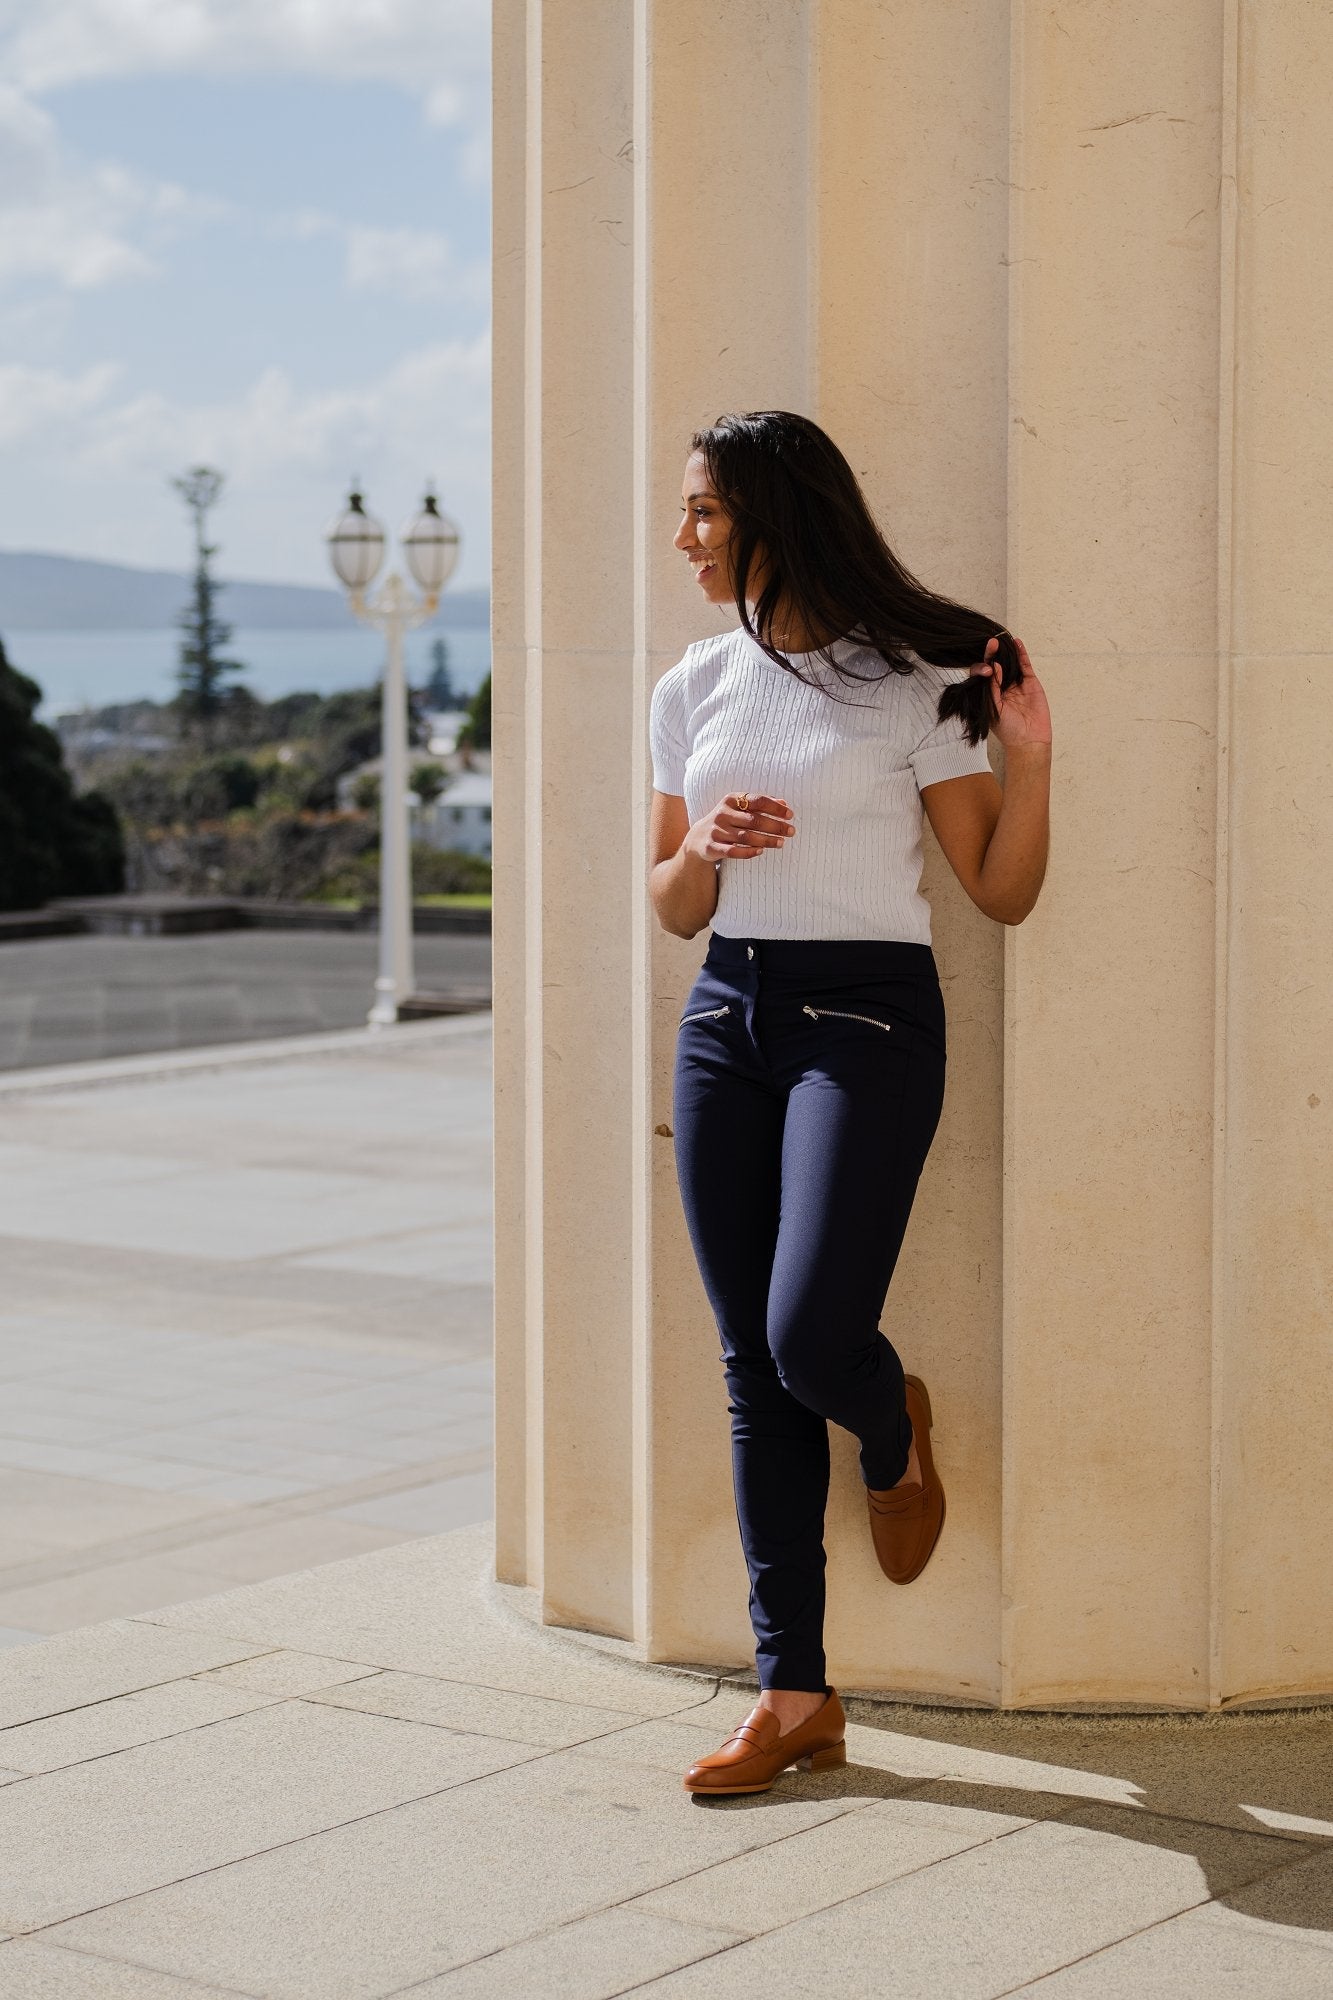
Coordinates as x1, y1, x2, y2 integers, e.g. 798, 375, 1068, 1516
16, 626, 490, 722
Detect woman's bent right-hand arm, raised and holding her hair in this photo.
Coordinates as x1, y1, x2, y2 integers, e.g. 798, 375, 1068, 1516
921, 640, 1051, 924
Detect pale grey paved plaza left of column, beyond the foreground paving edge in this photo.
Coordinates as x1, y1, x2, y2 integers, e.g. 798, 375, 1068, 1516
0, 1024, 492, 1646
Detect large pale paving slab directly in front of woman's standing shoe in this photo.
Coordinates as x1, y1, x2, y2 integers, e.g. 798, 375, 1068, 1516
44, 1724, 849, 2000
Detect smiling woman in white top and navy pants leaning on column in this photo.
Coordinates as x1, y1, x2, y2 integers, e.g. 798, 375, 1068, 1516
650, 410, 1051, 1792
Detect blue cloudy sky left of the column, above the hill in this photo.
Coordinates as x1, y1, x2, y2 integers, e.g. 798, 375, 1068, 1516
0, 0, 490, 584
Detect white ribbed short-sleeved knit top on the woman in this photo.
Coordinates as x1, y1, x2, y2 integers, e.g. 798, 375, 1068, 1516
650, 632, 991, 944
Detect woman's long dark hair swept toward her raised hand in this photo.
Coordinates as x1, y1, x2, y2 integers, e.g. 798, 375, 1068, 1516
691, 410, 1023, 744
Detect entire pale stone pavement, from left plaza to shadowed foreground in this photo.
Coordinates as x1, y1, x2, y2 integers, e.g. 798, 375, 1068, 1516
0, 1016, 1333, 2000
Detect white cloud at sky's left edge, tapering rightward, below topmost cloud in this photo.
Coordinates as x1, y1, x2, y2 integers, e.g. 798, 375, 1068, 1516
0, 86, 222, 292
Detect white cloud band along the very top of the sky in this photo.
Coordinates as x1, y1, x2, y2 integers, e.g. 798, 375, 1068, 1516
0, 0, 490, 145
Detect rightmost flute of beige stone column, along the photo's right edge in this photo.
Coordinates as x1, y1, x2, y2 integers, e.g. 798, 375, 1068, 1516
1209, 0, 1333, 1698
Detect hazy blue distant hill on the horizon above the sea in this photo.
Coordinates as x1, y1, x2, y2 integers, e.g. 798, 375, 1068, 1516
0, 550, 490, 632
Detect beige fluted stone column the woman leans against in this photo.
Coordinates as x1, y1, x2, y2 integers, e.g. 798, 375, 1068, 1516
494, 0, 1333, 1706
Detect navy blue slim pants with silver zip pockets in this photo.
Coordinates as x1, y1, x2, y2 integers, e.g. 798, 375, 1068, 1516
675, 934, 945, 1692
